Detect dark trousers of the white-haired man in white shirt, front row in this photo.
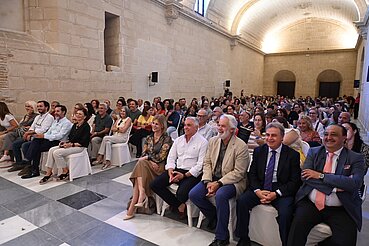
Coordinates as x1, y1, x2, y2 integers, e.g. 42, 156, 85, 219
150, 169, 201, 208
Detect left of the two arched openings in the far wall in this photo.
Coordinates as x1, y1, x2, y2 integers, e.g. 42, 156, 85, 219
274, 70, 296, 98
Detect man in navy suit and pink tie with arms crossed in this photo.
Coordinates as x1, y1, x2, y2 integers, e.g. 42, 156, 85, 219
288, 125, 364, 246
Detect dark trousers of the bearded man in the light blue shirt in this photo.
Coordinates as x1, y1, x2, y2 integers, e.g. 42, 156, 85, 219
23, 138, 60, 173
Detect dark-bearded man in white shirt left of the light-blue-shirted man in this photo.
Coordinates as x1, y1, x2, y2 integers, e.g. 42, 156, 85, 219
8, 101, 54, 172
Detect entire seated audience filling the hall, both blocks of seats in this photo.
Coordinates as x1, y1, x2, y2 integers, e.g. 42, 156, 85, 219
0, 92, 369, 245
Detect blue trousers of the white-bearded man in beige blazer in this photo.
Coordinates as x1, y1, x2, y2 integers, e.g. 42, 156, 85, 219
190, 182, 236, 240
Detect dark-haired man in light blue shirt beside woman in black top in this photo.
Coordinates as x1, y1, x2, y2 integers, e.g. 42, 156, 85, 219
22, 105, 73, 179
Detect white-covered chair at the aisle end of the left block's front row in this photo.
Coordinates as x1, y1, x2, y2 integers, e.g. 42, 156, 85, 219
111, 125, 132, 167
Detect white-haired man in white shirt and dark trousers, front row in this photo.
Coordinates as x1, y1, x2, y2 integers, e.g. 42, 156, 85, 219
150, 117, 208, 217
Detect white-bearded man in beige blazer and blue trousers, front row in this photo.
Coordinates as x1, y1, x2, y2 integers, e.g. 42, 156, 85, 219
190, 115, 250, 246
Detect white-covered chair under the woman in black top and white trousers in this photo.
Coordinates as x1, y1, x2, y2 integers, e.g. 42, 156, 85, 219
67, 148, 92, 181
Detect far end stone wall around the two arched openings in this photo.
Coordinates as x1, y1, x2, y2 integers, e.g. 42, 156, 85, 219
263, 50, 357, 97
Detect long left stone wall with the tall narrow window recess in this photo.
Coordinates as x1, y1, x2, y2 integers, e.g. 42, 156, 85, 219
0, 0, 264, 116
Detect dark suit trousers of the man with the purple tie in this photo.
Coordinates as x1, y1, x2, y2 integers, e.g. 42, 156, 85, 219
236, 190, 294, 245
